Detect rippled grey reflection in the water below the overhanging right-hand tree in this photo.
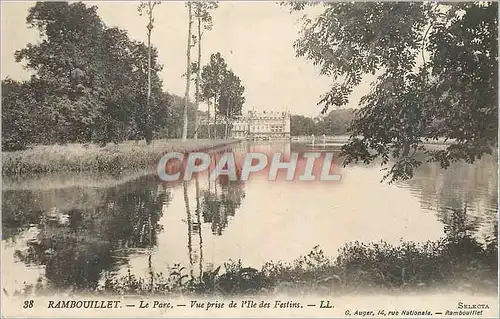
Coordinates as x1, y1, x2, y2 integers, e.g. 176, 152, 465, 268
398, 151, 498, 239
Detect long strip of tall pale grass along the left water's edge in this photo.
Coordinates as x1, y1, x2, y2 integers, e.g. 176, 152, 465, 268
2, 140, 237, 176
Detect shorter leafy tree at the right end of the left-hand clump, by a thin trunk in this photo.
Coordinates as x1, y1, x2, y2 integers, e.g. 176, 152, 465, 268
97, 28, 164, 145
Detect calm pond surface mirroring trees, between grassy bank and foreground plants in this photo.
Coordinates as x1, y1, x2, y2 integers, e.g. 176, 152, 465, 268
2, 142, 498, 296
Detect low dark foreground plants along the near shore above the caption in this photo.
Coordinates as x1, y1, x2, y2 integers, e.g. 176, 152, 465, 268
11, 211, 498, 296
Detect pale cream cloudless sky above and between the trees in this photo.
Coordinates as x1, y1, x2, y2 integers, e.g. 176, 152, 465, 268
2, 1, 369, 116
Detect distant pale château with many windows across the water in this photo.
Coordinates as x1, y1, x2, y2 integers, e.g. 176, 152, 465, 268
200, 110, 290, 140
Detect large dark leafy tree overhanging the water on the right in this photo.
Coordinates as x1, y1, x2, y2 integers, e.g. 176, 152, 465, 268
287, 2, 498, 182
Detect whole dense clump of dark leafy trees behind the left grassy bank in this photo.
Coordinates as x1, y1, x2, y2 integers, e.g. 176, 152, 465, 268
2, 2, 171, 150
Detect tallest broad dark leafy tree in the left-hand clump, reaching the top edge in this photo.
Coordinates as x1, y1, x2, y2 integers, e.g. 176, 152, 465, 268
13, 2, 105, 143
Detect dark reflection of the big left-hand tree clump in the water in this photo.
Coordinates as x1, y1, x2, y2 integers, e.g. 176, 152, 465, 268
11, 177, 170, 290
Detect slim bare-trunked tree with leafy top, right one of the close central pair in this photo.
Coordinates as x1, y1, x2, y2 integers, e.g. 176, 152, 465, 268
194, 1, 218, 140
